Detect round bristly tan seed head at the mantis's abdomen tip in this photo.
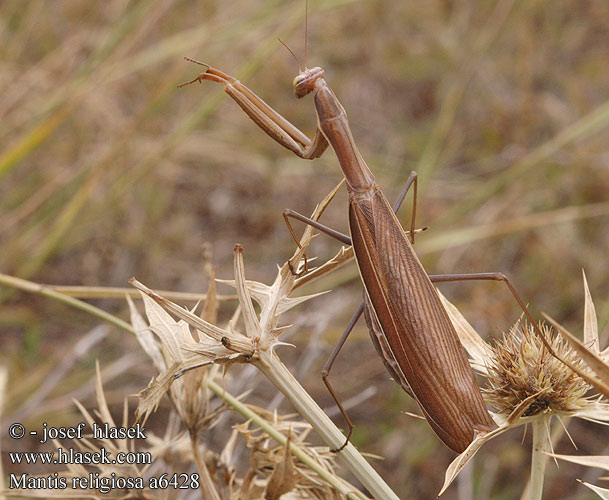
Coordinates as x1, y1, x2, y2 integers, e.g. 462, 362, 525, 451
483, 323, 590, 416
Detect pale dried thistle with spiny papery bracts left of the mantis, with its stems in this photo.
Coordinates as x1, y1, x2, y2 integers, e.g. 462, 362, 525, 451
131, 185, 397, 500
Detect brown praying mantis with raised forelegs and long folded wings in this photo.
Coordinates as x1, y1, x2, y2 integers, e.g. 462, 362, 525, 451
180, 58, 541, 452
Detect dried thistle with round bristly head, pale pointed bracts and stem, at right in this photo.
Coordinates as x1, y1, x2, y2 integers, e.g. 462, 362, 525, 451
440, 276, 609, 499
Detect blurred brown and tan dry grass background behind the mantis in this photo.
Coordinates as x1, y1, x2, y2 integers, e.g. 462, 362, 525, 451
0, 0, 609, 499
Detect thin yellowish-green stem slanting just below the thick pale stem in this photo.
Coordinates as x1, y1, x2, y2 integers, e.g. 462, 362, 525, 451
207, 380, 366, 500
